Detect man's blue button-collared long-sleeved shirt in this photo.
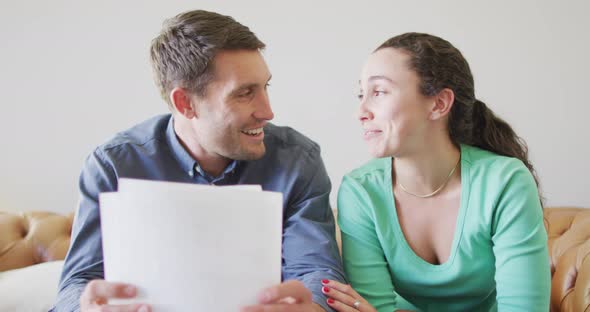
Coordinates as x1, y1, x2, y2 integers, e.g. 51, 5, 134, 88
55, 115, 345, 311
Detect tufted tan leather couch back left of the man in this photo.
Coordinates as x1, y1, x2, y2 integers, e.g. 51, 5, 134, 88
0, 211, 74, 272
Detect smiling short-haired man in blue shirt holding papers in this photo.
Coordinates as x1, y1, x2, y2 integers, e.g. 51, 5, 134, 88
55, 11, 344, 311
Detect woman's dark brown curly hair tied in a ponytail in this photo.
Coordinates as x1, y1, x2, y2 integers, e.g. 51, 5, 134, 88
376, 33, 543, 204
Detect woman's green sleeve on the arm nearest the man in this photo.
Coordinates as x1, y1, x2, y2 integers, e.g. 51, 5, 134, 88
338, 176, 418, 312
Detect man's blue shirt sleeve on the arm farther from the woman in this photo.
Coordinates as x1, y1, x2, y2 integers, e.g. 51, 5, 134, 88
52, 149, 116, 312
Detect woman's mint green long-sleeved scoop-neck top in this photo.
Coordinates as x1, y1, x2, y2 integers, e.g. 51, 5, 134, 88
338, 145, 551, 312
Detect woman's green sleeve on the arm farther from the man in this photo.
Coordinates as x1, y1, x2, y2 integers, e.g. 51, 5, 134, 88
492, 160, 551, 312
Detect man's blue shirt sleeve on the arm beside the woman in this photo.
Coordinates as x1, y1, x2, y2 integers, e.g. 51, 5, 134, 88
282, 145, 346, 311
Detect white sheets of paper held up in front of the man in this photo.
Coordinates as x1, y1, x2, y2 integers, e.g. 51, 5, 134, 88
100, 180, 282, 312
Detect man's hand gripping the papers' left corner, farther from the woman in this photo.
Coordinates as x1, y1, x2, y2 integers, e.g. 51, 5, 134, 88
80, 280, 151, 312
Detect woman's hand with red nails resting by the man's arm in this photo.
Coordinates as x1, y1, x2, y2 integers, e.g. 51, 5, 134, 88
322, 280, 377, 312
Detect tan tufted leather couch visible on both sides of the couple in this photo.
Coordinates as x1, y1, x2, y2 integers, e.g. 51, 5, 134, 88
0, 207, 590, 312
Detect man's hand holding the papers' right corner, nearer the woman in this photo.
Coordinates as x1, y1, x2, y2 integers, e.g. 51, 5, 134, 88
241, 280, 325, 312
